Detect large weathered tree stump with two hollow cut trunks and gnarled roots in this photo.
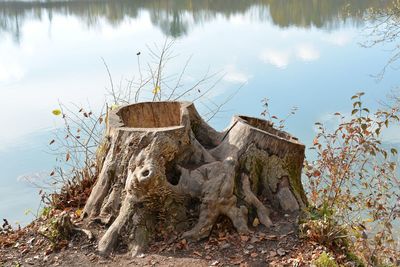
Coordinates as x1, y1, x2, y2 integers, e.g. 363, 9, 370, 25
83, 102, 306, 254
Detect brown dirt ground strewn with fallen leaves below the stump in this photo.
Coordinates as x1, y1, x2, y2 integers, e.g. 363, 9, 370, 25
0, 214, 325, 266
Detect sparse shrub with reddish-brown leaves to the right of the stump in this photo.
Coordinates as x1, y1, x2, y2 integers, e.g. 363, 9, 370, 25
302, 93, 400, 266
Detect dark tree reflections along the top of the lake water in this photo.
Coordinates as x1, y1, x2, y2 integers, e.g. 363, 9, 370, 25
0, 0, 395, 42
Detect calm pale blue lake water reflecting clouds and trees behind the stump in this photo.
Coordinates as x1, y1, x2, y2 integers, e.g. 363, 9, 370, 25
0, 0, 400, 227
